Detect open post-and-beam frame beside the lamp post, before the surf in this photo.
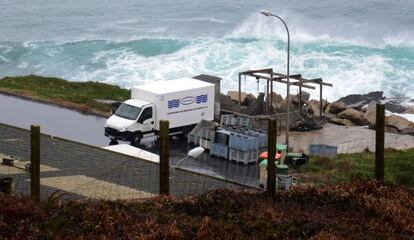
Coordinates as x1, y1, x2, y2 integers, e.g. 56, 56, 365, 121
238, 68, 333, 118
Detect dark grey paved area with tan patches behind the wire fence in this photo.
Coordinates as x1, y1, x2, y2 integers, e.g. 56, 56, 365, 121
0, 124, 253, 199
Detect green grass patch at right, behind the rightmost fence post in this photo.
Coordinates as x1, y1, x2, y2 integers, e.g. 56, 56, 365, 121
298, 149, 414, 187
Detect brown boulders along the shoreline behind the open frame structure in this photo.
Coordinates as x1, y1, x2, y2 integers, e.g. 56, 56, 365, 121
221, 91, 414, 135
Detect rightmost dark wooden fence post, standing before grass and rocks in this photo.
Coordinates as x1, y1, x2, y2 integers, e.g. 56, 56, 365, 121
375, 104, 385, 182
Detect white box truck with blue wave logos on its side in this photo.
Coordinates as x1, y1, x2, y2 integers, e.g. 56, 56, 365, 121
105, 78, 215, 146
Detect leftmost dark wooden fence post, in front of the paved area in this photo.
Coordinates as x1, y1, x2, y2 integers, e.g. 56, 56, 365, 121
30, 125, 40, 201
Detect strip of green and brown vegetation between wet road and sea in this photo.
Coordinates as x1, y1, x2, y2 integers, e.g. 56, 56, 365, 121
0, 75, 130, 114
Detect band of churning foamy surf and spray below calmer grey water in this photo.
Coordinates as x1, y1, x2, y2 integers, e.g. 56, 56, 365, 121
2, 14, 414, 101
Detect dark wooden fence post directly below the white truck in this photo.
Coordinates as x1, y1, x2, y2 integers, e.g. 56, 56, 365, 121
159, 120, 170, 195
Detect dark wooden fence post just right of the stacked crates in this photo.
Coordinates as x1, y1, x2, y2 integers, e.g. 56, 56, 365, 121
266, 119, 276, 197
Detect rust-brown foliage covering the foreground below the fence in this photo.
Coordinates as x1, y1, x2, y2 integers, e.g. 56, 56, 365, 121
0, 181, 414, 239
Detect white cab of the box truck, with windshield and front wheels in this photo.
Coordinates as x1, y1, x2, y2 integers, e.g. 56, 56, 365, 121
105, 99, 156, 146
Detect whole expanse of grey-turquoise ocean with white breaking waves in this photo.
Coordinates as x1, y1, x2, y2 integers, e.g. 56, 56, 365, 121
0, 0, 414, 100
